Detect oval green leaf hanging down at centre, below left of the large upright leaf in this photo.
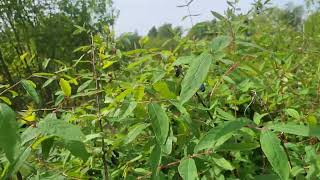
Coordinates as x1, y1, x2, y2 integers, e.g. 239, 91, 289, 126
148, 103, 169, 144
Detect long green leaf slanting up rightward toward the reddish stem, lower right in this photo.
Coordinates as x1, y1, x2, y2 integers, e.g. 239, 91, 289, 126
194, 119, 250, 152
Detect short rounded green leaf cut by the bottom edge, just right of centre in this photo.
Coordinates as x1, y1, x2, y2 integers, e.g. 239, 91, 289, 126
178, 158, 198, 180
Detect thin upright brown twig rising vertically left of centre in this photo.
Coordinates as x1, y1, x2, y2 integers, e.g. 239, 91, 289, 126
91, 34, 109, 180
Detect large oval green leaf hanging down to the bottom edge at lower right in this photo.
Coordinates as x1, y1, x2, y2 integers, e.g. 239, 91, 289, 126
260, 130, 290, 180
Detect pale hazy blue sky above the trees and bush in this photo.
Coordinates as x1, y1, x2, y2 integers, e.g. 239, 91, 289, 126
114, 0, 303, 35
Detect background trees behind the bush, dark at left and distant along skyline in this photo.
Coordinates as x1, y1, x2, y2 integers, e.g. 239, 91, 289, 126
0, 0, 319, 84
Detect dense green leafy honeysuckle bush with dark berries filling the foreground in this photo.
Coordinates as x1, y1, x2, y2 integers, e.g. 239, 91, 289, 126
0, 0, 320, 180
